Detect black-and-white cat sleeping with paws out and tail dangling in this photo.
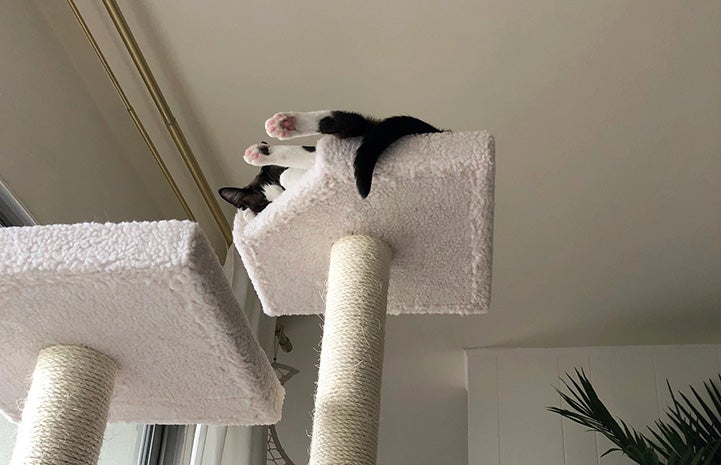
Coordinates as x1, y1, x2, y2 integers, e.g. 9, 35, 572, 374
219, 111, 441, 213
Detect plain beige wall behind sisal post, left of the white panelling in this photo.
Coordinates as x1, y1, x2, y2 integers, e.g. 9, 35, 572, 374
277, 316, 468, 465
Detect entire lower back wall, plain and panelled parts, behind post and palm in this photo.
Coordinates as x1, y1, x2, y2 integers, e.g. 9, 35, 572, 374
277, 317, 721, 465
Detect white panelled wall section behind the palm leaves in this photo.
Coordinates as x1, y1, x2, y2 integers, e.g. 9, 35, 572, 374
467, 345, 721, 465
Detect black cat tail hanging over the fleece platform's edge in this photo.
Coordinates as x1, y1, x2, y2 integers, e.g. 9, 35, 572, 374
353, 116, 441, 198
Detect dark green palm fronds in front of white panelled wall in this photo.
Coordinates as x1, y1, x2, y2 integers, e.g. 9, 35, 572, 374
548, 369, 721, 465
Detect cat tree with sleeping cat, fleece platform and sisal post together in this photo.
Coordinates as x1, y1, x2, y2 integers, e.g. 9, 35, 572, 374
234, 132, 495, 465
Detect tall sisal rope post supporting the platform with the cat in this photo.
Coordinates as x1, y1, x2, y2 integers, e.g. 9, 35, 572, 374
310, 236, 391, 465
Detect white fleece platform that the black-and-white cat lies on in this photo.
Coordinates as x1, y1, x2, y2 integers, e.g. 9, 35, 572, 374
234, 131, 495, 315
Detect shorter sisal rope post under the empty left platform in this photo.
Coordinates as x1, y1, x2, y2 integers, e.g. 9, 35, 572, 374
10, 345, 117, 465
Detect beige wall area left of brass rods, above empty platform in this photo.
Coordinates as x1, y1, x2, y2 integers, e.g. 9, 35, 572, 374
0, 1, 188, 227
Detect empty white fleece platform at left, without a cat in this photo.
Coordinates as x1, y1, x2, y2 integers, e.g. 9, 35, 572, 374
0, 221, 283, 425
